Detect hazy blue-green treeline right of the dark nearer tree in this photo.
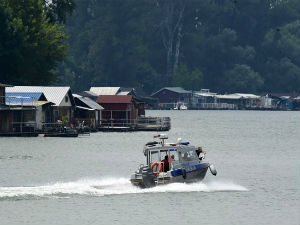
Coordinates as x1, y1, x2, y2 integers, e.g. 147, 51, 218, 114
60, 0, 300, 92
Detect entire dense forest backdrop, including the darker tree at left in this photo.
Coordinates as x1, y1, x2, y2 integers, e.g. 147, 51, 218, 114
0, 0, 300, 93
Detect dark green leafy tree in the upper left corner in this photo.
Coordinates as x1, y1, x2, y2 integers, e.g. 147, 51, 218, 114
0, 0, 67, 85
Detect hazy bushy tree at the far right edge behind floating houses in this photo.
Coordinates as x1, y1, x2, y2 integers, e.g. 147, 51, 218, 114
263, 20, 300, 92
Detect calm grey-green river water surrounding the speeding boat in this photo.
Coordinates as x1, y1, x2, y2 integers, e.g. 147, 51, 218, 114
0, 111, 300, 225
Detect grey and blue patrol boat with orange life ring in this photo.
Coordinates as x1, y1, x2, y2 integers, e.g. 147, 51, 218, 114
130, 134, 217, 188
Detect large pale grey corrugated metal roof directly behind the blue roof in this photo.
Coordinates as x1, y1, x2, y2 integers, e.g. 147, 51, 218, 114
5, 86, 70, 106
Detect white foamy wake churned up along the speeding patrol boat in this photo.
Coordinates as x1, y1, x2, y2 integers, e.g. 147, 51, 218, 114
0, 178, 248, 200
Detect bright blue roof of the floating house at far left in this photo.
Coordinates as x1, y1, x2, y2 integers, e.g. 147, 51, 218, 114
5, 92, 46, 103
